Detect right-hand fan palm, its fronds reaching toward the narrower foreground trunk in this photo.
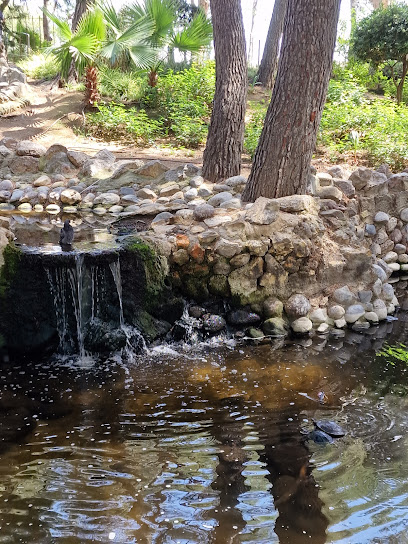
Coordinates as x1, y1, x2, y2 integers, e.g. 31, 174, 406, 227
124, 0, 212, 87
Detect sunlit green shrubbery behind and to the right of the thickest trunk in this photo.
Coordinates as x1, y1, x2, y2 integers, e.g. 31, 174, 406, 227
244, 78, 408, 169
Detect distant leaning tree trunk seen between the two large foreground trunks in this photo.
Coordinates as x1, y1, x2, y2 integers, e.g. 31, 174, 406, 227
258, 0, 288, 89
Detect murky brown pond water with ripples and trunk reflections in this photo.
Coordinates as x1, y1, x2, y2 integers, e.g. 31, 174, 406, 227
0, 313, 408, 544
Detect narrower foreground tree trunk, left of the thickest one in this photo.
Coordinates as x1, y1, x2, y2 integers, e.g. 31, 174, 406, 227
203, 0, 248, 181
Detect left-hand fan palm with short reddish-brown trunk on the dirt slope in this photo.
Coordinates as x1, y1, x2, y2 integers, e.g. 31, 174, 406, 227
44, 2, 156, 105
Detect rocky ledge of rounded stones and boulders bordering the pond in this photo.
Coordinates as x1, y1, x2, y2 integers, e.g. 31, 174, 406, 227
0, 138, 408, 337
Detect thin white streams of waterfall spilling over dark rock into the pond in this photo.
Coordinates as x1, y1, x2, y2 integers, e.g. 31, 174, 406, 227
46, 254, 146, 359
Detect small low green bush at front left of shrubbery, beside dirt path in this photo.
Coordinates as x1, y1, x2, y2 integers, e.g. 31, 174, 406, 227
87, 102, 163, 144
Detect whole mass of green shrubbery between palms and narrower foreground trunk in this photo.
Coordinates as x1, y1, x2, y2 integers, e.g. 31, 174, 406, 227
88, 62, 215, 147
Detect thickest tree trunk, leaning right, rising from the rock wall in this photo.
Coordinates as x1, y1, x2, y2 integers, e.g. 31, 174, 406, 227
242, 0, 340, 202
